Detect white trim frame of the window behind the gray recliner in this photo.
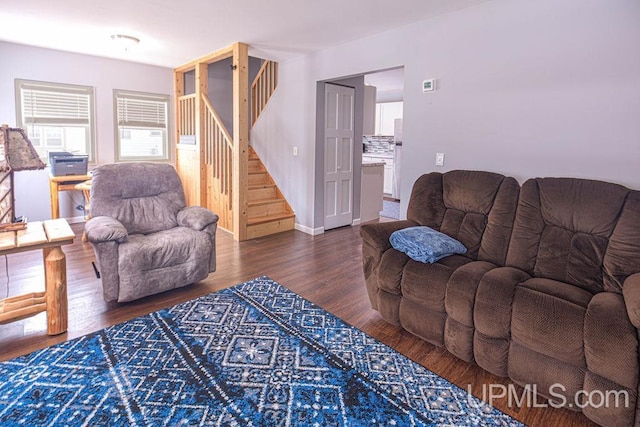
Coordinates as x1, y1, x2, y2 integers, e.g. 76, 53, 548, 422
113, 89, 172, 162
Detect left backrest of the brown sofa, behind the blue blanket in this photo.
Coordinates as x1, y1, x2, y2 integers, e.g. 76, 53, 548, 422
407, 170, 520, 265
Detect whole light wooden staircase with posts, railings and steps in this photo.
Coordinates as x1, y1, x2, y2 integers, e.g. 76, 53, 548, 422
174, 43, 295, 241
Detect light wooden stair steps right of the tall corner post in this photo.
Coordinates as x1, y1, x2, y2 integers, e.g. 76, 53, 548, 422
247, 147, 295, 239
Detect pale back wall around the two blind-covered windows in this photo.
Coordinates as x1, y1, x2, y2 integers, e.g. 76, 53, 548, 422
0, 42, 174, 221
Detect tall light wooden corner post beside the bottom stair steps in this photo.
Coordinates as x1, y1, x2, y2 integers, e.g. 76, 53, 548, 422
233, 43, 249, 241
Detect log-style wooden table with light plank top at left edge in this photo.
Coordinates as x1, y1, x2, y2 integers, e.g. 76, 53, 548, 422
0, 218, 76, 335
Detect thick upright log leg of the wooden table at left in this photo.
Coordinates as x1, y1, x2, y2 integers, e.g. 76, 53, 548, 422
43, 246, 67, 335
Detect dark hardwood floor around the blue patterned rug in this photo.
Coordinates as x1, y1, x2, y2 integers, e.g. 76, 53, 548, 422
0, 224, 595, 426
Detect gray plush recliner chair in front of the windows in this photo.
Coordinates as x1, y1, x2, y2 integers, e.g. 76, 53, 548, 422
85, 163, 218, 302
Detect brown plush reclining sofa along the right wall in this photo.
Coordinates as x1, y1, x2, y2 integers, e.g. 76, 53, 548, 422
360, 171, 640, 426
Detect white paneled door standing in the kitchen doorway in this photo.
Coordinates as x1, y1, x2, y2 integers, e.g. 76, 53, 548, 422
324, 83, 355, 230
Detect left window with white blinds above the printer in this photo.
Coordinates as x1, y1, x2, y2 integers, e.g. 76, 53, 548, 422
15, 79, 95, 162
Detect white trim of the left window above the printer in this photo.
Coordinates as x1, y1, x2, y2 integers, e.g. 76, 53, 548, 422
15, 79, 96, 164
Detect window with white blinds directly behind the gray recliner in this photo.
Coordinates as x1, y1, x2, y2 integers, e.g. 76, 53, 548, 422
113, 90, 169, 161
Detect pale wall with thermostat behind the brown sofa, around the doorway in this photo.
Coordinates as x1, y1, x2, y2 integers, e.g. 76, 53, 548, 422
254, 0, 640, 230
